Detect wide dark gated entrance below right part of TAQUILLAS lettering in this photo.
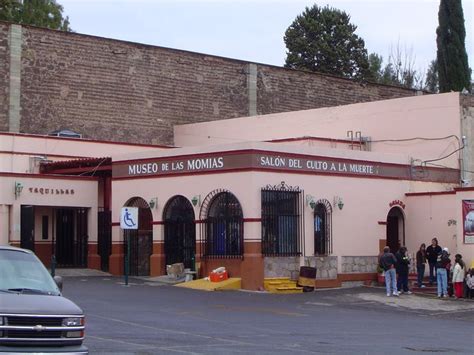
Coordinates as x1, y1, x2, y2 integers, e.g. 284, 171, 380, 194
53, 208, 88, 267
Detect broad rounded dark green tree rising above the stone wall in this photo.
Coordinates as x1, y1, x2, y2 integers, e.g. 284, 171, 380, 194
284, 5, 369, 79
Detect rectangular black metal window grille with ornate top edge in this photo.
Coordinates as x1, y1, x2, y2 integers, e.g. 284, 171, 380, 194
261, 182, 304, 256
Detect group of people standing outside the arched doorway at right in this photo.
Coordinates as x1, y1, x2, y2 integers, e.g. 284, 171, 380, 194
379, 238, 474, 298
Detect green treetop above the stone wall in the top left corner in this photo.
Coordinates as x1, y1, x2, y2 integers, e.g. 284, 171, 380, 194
0, 0, 71, 31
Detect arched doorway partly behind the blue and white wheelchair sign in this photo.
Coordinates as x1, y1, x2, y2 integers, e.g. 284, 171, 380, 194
124, 197, 153, 276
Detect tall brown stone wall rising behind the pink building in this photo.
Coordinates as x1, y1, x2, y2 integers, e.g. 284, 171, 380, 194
0, 22, 422, 144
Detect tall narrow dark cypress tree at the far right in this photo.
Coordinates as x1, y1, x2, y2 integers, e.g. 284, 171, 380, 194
436, 0, 471, 92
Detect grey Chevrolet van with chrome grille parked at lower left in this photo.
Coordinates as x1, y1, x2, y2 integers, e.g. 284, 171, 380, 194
0, 246, 88, 354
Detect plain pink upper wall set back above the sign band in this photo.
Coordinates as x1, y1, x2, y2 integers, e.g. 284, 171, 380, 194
174, 93, 461, 167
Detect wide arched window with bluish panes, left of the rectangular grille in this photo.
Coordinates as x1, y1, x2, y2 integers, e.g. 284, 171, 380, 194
203, 191, 244, 258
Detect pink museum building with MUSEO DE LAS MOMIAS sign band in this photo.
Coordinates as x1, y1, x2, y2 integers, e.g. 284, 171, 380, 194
0, 93, 474, 289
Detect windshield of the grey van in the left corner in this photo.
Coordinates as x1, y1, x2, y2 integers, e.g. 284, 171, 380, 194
0, 250, 60, 295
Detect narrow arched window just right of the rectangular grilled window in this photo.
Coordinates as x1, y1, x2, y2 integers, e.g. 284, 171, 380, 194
314, 200, 332, 255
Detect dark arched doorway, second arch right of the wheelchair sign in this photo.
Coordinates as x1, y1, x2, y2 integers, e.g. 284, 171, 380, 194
163, 196, 196, 269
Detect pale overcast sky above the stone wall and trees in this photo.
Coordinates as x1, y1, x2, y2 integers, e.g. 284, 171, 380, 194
58, 0, 474, 77
